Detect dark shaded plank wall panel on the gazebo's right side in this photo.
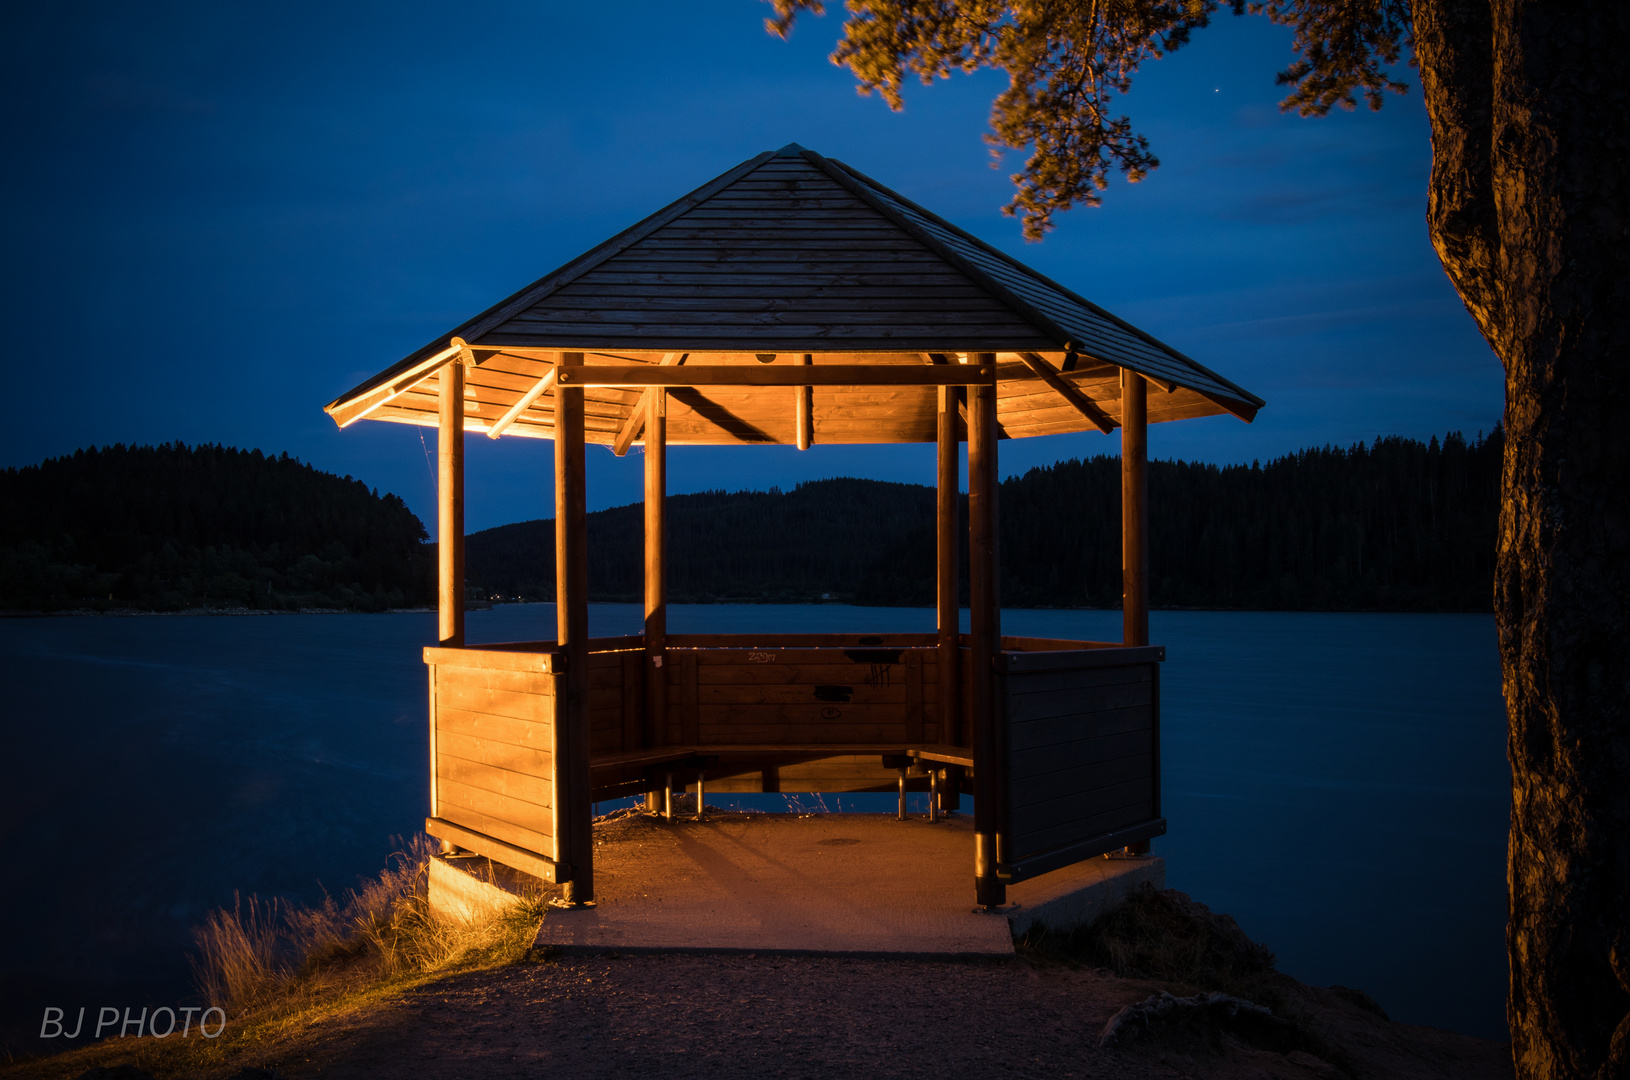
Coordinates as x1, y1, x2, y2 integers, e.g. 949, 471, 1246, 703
1001, 650, 1165, 881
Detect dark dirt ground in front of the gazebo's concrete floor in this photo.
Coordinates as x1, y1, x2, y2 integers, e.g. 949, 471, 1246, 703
70, 956, 1511, 1080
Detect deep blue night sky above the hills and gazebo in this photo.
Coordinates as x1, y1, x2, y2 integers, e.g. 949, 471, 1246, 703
0, 0, 1501, 529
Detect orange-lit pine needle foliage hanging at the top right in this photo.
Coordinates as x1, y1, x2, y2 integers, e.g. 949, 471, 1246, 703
764, 0, 1413, 239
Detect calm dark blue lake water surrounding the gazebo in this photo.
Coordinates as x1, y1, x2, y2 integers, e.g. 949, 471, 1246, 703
0, 604, 1509, 1052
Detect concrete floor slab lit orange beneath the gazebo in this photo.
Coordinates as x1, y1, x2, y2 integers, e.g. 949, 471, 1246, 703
515, 813, 1164, 959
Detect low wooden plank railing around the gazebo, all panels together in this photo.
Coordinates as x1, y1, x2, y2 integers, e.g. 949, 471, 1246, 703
425, 634, 1164, 881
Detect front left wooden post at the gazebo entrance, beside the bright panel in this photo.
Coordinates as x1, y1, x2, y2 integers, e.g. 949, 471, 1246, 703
554, 352, 595, 904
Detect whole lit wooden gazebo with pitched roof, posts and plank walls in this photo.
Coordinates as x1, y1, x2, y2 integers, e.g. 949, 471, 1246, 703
328, 143, 1263, 907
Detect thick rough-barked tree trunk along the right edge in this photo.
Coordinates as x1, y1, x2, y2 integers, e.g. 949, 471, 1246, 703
1415, 0, 1630, 1080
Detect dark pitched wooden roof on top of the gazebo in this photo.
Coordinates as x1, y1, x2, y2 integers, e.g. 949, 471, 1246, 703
329, 143, 1263, 441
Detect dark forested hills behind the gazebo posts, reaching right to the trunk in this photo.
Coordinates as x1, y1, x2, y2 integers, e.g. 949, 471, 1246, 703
466, 430, 1503, 611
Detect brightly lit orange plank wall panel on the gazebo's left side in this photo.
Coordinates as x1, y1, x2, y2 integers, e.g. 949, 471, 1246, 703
427, 650, 557, 880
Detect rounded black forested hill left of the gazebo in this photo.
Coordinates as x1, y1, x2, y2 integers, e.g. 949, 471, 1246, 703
0, 443, 435, 611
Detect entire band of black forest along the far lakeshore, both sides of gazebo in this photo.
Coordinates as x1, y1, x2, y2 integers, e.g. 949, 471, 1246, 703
0, 430, 1501, 611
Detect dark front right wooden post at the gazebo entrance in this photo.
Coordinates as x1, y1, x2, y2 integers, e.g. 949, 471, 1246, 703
968, 353, 1007, 909
